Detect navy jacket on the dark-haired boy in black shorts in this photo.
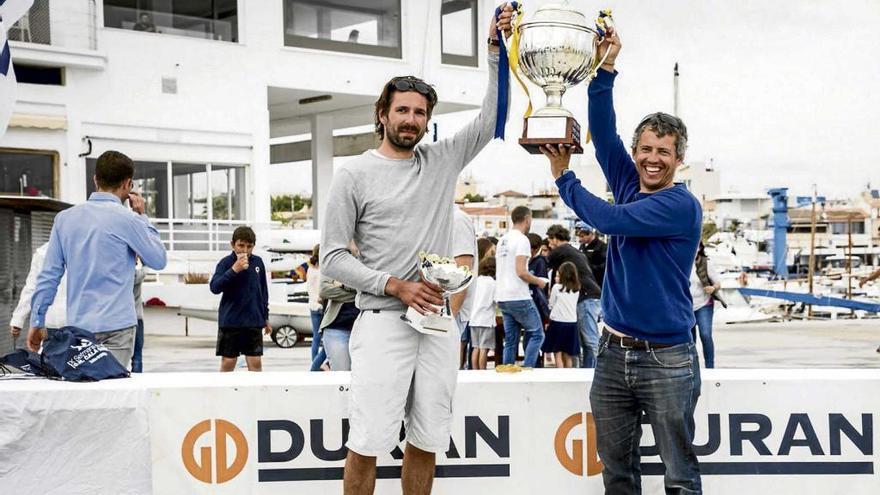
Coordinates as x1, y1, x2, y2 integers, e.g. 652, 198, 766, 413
211, 252, 269, 328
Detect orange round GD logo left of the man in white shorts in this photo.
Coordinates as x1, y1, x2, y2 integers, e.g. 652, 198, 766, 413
180, 419, 248, 483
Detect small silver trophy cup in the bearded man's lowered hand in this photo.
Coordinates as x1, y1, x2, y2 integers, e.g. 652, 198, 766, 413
401, 251, 474, 333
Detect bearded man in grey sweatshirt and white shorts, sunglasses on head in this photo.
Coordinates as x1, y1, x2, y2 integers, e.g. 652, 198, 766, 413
321, 5, 512, 495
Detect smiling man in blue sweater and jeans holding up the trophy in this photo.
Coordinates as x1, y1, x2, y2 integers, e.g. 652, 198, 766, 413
544, 30, 702, 495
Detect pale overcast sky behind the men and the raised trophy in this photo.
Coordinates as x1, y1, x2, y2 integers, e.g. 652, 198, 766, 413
273, 0, 880, 202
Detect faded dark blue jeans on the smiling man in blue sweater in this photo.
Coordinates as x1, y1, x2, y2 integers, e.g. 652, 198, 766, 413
590, 333, 702, 495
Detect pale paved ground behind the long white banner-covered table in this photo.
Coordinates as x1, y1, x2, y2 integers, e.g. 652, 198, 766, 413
144, 313, 880, 371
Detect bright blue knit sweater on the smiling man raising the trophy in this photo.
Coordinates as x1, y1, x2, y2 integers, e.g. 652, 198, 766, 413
556, 70, 703, 344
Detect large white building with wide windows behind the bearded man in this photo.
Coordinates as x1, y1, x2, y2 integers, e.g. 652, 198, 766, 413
0, 0, 494, 250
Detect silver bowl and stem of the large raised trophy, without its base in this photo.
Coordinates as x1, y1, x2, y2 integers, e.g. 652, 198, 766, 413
519, 4, 599, 117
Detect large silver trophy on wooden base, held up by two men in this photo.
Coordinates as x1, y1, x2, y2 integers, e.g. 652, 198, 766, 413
518, 2, 607, 154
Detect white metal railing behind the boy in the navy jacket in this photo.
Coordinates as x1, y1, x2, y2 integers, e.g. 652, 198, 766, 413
150, 218, 281, 251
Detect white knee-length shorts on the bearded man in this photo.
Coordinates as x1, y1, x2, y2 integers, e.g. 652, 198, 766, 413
346, 310, 460, 457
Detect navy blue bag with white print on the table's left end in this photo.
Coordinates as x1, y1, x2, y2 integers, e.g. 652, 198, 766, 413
2, 327, 129, 382
